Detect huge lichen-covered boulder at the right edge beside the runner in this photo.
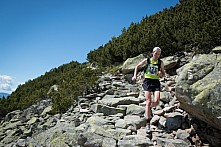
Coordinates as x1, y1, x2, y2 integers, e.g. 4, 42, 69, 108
175, 54, 221, 130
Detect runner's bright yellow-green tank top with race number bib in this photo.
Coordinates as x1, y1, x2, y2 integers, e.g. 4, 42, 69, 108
144, 59, 160, 79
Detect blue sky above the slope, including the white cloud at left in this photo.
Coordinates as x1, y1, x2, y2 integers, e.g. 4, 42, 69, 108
0, 0, 179, 93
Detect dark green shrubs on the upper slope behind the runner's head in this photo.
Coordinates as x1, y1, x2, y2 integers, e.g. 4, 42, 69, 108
87, 0, 221, 66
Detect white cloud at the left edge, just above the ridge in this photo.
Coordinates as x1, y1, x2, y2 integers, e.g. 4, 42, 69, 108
0, 75, 14, 93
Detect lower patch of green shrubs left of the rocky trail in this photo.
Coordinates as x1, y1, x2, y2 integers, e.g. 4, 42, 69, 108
0, 61, 101, 117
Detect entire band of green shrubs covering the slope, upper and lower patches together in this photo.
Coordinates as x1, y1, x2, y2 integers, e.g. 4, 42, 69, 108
0, 0, 221, 117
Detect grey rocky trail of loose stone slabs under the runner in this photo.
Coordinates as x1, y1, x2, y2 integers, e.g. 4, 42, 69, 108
0, 51, 221, 147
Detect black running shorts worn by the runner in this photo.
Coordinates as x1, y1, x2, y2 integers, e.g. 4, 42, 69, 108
143, 78, 160, 92
